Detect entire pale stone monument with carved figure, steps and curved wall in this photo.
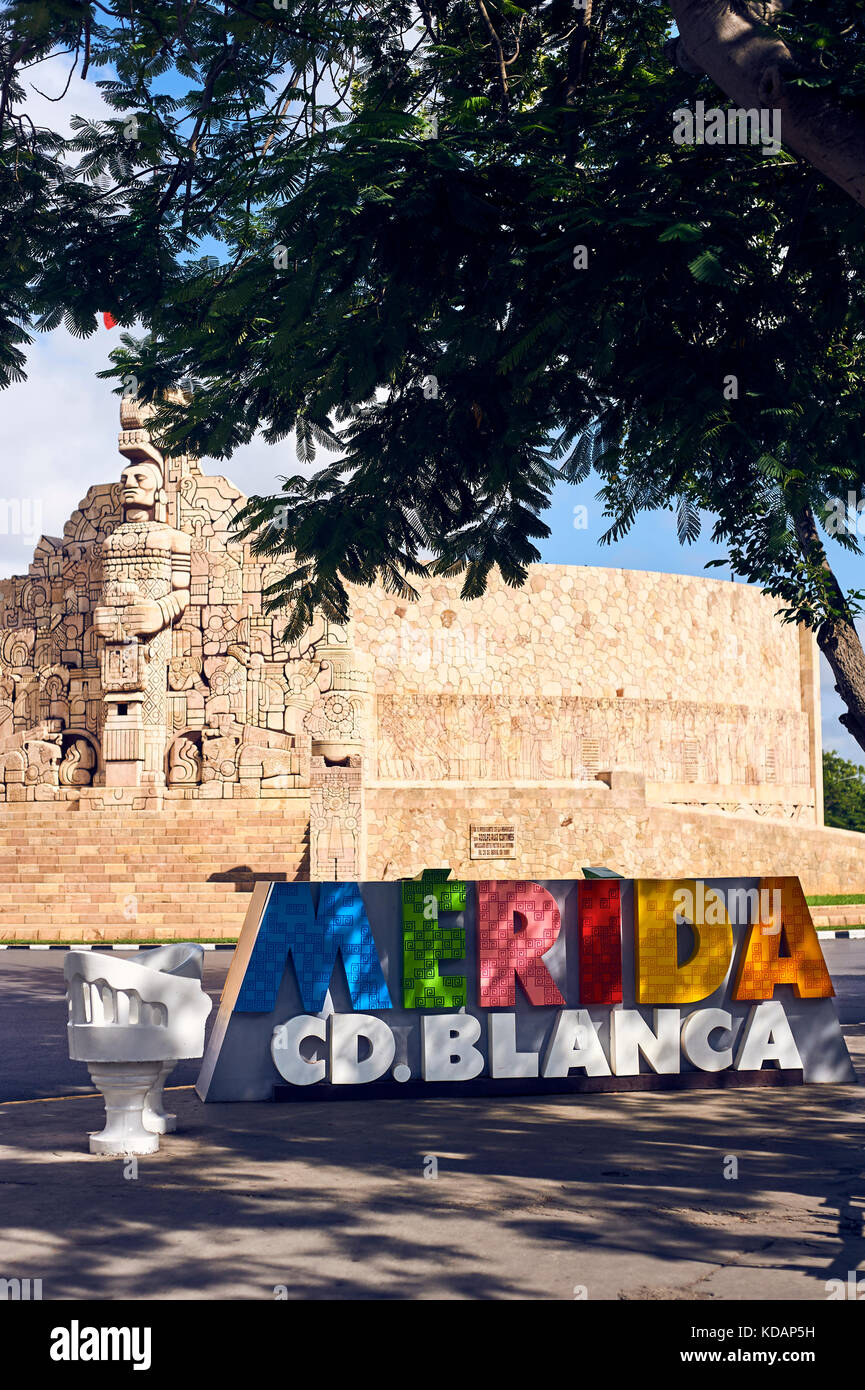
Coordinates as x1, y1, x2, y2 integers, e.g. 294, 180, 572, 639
0, 386, 865, 941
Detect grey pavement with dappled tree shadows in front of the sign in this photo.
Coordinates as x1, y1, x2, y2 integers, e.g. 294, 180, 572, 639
0, 942, 865, 1301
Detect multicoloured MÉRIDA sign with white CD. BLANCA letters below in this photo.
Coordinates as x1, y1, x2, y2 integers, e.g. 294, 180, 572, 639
197, 870, 854, 1101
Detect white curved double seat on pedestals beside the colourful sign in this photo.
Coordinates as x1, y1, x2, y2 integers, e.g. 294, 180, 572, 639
64, 941, 213, 1154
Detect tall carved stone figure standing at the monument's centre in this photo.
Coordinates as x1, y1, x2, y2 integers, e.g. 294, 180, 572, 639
93, 431, 191, 787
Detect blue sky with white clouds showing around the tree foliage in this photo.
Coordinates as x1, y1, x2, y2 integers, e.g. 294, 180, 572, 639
0, 60, 865, 762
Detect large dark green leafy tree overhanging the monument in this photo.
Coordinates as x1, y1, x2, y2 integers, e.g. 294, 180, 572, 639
0, 0, 865, 748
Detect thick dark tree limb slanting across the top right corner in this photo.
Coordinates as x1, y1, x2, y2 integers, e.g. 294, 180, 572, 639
670, 0, 865, 206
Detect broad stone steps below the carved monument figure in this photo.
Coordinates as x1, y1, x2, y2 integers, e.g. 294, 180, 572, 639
0, 798, 309, 942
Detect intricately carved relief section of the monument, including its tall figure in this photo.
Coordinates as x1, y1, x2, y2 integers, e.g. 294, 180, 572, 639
0, 398, 370, 874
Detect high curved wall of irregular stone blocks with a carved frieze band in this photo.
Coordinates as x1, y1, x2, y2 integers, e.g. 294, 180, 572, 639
353, 564, 822, 824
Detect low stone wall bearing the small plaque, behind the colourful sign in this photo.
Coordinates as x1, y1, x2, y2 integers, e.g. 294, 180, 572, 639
367, 773, 865, 894
